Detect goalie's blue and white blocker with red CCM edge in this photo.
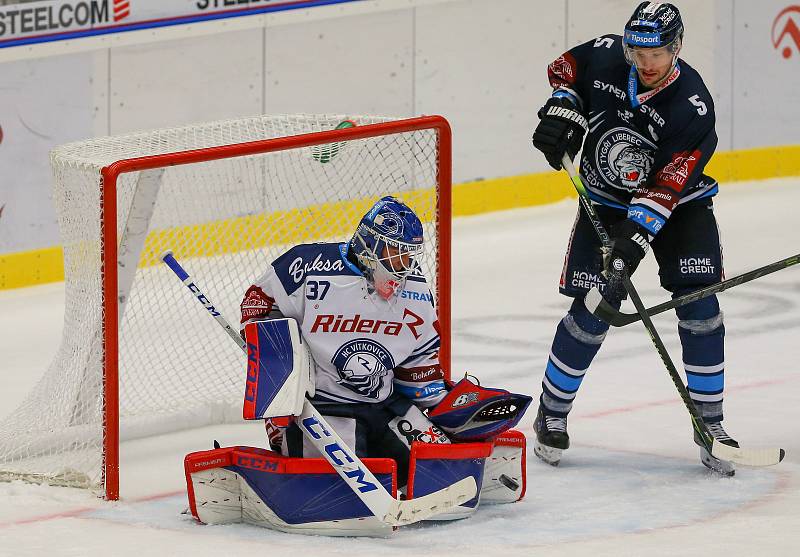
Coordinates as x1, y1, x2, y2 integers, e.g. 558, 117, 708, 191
242, 318, 315, 420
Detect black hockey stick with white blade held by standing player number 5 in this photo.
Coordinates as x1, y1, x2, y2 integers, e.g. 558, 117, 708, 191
561, 155, 785, 466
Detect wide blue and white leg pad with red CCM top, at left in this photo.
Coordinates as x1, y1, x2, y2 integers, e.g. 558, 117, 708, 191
184, 447, 397, 536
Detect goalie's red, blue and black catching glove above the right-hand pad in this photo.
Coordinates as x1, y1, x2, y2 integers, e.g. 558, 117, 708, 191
428, 377, 532, 441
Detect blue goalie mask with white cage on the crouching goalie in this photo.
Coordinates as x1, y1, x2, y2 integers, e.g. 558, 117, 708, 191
350, 196, 423, 300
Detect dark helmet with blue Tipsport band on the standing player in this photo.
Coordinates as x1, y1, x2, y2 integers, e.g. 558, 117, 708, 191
622, 2, 683, 53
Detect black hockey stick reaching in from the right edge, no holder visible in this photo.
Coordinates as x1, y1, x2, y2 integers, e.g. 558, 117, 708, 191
584, 254, 800, 327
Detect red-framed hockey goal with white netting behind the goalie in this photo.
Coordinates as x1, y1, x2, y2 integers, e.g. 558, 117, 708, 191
0, 115, 451, 500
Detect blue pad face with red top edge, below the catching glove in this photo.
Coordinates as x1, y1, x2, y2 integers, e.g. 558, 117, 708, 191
407, 442, 492, 520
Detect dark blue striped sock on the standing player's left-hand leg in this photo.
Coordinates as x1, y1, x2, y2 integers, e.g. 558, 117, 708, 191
540, 299, 608, 417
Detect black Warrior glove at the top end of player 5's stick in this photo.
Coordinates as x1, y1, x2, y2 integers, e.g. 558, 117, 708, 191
533, 97, 588, 170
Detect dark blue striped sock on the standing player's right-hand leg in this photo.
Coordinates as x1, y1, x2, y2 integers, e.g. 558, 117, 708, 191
674, 290, 725, 423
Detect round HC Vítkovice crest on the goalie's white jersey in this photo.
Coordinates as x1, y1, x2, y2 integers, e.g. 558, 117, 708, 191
331, 338, 394, 399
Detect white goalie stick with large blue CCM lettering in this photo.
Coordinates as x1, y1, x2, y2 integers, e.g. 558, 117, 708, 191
161, 251, 478, 526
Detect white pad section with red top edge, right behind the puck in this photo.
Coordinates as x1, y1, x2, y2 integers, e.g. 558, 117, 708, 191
481, 429, 527, 504
